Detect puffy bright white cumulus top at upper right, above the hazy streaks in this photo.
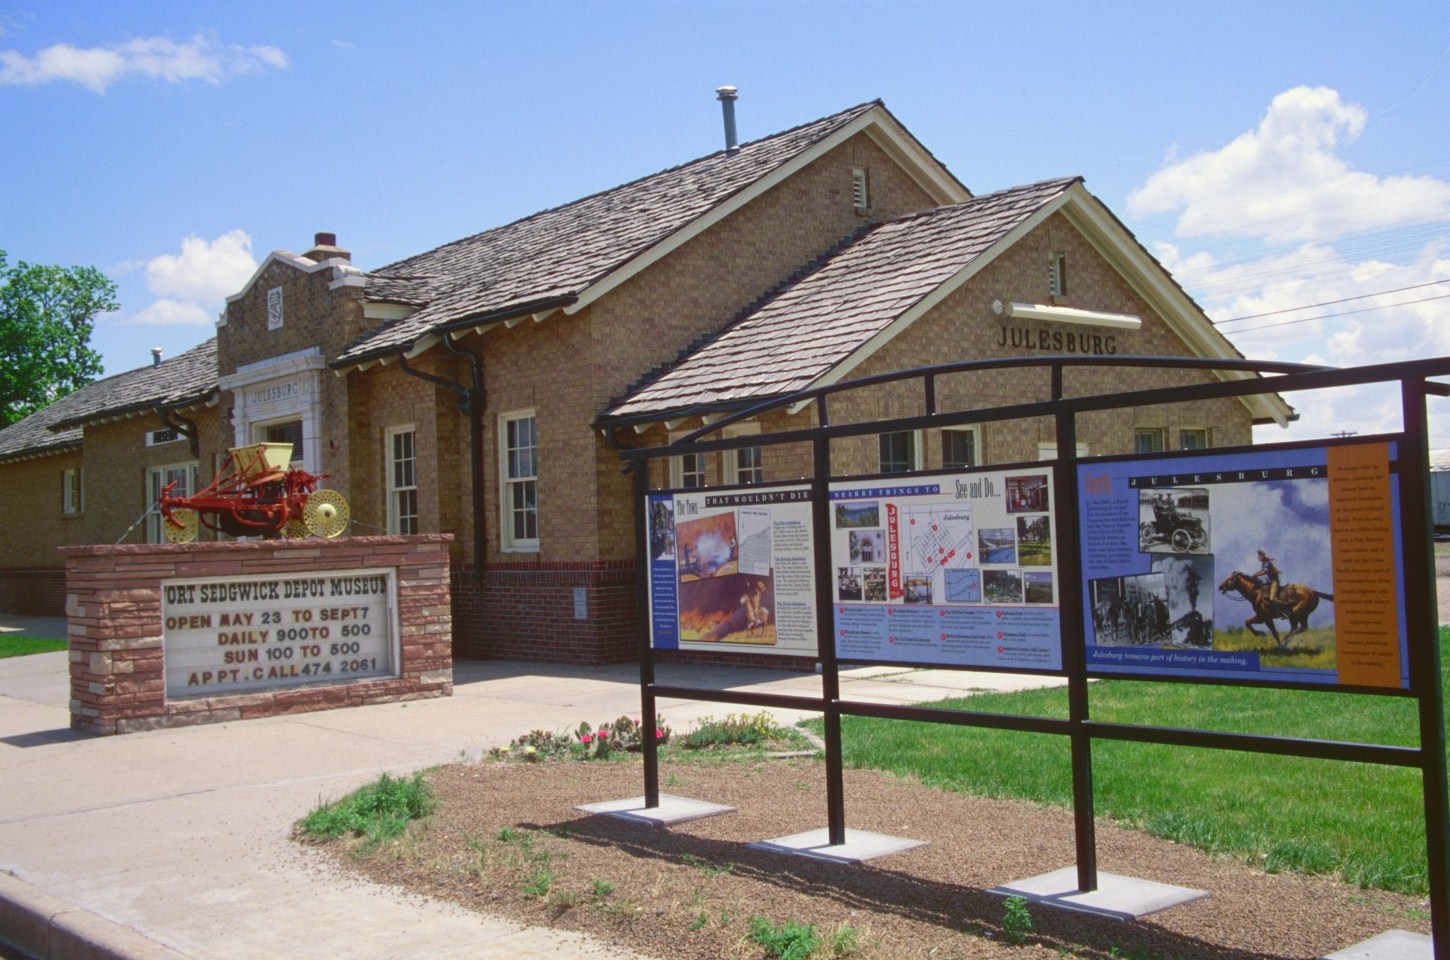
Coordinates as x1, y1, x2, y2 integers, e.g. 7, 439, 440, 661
1128, 87, 1450, 242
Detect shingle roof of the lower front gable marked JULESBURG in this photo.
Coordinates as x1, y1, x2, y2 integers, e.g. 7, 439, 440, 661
600, 177, 1080, 423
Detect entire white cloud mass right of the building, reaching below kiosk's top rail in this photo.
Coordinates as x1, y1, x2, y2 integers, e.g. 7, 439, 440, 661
1130, 87, 1450, 447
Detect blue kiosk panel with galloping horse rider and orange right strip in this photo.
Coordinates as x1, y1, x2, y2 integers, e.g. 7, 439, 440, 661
1077, 442, 1408, 689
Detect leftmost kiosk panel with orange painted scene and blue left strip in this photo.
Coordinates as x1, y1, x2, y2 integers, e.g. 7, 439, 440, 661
647, 486, 816, 657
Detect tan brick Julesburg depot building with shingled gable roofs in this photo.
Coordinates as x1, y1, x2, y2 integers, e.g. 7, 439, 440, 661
0, 102, 1292, 663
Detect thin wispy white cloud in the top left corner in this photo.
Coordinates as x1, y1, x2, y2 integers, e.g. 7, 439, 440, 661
0, 33, 287, 93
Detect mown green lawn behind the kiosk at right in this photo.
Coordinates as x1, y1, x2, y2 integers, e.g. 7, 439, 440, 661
818, 629, 1450, 893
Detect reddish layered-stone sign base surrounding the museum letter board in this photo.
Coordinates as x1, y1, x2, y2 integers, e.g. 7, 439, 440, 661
61, 535, 452, 734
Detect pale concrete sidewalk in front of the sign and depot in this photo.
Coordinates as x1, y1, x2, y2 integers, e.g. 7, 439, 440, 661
0, 629, 1051, 960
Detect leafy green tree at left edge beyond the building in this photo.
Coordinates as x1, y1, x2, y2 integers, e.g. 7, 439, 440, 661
0, 249, 120, 426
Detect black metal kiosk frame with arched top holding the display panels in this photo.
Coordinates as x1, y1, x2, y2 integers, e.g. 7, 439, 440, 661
619, 355, 1450, 960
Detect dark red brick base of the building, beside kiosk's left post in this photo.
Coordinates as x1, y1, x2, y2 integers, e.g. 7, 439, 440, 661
452, 560, 639, 666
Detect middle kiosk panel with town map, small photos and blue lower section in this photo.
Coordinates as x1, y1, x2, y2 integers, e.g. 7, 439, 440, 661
831, 468, 1063, 670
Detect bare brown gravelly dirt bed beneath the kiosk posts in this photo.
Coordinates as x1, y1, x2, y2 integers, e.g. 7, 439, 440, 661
303, 760, 1428, 960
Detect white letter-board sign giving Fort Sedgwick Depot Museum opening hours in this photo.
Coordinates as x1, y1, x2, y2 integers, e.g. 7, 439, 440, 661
161, 568, 399, 698
